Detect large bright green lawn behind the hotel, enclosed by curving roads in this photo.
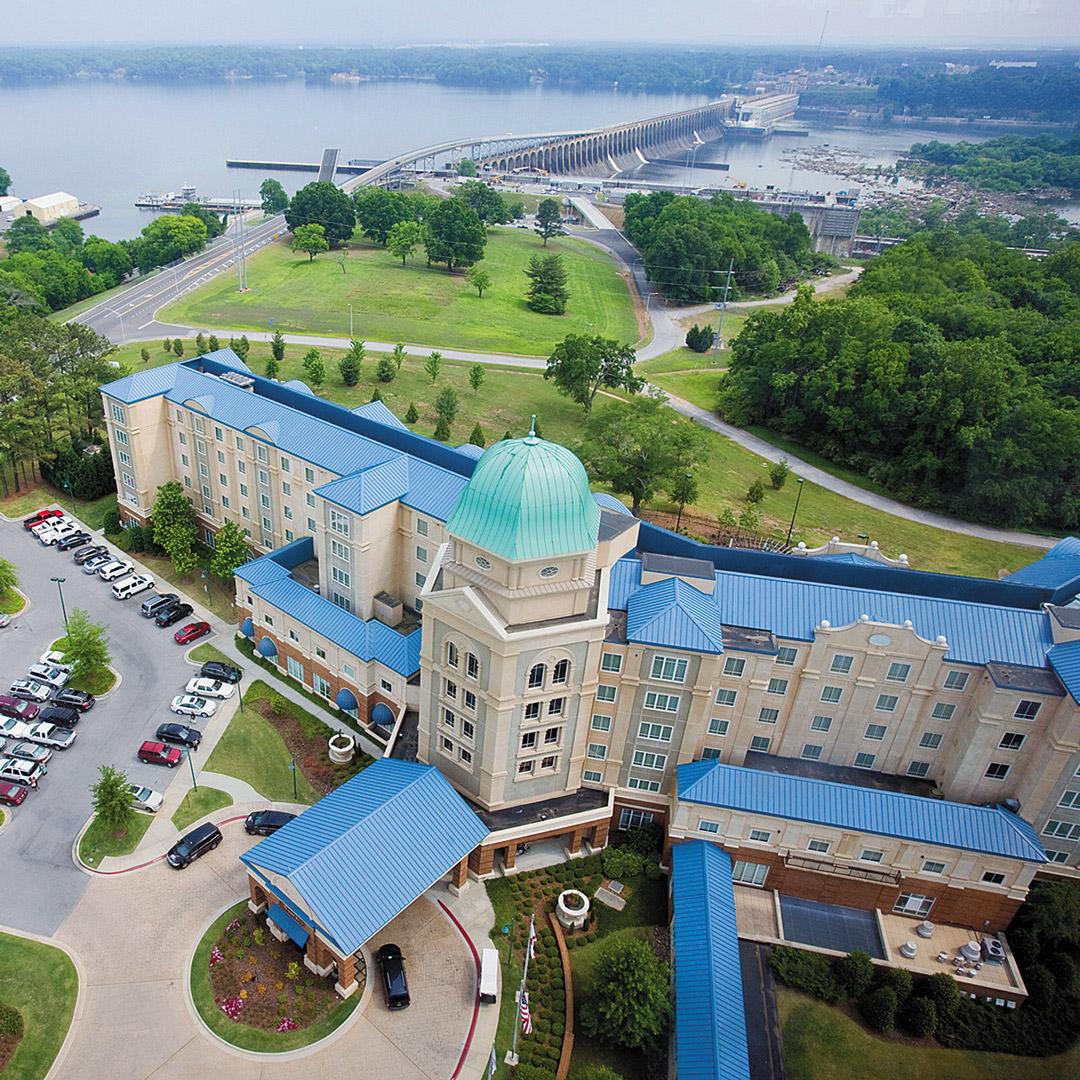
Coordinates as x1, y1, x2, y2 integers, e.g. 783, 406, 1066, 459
161, 228, 639, 355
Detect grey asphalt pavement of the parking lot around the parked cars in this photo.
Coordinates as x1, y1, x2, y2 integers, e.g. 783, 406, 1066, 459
0, 505, 219, 935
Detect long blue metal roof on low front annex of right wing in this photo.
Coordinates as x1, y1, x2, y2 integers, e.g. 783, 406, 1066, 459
678, 760, 1047, 863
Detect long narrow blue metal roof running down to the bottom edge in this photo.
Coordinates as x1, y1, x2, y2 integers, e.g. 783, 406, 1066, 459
672, 840, 750, 1080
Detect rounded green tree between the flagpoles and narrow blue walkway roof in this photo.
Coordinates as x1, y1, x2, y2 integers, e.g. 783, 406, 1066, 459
581, 937, 671, 1050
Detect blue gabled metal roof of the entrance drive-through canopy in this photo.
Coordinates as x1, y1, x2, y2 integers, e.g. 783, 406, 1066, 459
240, 758, 487, 955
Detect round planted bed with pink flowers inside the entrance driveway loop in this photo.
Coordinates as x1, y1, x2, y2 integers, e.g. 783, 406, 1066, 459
191, 902, 363, 1053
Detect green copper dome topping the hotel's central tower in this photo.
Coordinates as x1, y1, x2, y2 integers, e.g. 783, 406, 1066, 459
446, 435, 600, 561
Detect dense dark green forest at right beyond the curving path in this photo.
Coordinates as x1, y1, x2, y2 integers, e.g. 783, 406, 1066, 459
718, 229, 1080, 529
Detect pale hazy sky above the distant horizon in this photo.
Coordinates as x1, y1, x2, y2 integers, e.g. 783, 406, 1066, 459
8, 0, 1080, 46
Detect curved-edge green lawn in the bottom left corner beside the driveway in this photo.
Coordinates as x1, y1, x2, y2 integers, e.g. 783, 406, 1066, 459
0, 934, 79, 1080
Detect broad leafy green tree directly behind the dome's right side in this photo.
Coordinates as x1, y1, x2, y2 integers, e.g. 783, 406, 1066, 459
578, 396, 707, 514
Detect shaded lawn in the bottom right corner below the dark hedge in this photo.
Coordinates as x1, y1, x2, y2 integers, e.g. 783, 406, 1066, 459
777, 986, 1080, 1080
